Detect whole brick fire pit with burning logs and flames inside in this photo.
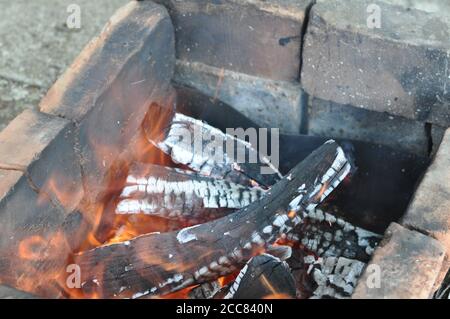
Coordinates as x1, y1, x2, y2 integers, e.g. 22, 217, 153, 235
0, 0, 450, 299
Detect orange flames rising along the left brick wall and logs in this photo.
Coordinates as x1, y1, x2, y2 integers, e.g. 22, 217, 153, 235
6, 96, 246, 299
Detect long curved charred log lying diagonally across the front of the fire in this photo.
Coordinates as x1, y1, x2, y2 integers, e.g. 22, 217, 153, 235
74, 141, 351, 298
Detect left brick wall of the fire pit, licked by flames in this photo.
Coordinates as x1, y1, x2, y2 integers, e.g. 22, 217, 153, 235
0, 1, 175, 297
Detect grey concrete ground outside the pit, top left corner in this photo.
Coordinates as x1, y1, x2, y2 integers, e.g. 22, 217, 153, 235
0, 0, 129, 130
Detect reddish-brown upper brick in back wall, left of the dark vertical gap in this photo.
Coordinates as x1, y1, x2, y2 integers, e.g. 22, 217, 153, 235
156, 0, 312, 81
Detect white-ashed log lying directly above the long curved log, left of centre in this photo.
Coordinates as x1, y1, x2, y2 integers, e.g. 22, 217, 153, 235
116, 163, 265, 224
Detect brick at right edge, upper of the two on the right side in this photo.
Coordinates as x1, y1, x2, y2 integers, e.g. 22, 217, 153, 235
402, 129, 450, 254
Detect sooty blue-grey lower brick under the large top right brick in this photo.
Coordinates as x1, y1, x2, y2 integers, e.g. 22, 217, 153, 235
308, 98, 428, 156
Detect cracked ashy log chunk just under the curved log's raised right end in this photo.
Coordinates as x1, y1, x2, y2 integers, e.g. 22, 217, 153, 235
287, 209, 382, 262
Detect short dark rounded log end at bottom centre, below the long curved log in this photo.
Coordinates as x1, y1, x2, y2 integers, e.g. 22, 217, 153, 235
225, 254, 296, 299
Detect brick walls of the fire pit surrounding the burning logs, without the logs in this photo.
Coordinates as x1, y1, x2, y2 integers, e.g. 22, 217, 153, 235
0, 0, 450, 298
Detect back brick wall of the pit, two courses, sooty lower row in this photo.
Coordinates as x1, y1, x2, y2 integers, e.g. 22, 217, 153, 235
158, 0, 450, 155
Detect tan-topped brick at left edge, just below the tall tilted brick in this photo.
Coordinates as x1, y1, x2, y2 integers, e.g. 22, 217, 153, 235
0, 110, 83, 211
